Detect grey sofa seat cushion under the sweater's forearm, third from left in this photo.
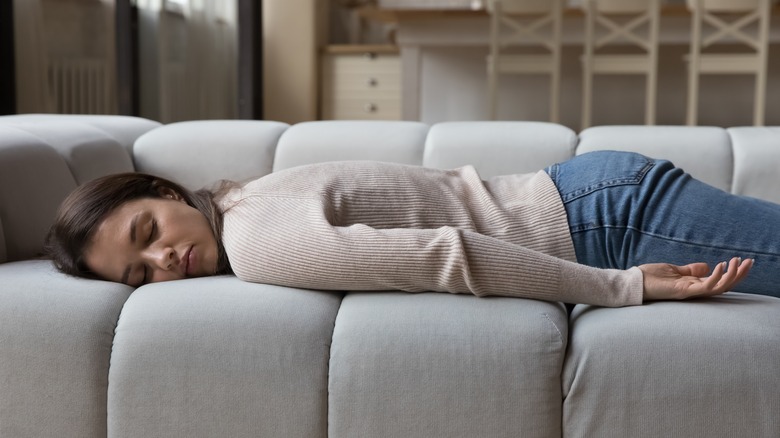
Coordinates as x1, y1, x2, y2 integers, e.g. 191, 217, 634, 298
328, 292, 567, 437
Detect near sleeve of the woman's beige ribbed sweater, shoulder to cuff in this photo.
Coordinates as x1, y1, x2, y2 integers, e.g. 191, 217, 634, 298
223, 197, 643, 307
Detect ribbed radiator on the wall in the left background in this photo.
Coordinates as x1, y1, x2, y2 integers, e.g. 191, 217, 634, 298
48, 59, 115, 114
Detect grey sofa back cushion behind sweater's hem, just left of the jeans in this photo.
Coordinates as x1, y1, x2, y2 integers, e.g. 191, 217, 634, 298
423, 122, 577, 179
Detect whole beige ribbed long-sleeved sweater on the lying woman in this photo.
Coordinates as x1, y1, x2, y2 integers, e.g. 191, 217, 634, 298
219, 161, 643, 306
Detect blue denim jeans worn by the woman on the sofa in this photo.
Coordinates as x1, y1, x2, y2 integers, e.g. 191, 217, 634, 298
546, 151, 780, 297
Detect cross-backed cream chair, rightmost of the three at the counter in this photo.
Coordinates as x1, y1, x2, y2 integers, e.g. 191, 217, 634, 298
686, 0, 772, 126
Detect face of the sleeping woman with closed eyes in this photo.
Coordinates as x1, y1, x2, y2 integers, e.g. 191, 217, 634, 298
84, 193, 218, 286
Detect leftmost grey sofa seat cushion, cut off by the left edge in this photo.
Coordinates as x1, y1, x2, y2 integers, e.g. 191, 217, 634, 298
0, 260, 132, 438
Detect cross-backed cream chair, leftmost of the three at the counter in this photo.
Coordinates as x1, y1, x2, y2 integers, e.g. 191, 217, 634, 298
487, 0, 563, 122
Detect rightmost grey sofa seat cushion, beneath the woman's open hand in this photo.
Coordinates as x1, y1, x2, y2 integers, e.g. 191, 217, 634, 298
563, 292, 780, 437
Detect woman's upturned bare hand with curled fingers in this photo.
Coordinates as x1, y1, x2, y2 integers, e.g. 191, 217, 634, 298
639, 257, 753, 301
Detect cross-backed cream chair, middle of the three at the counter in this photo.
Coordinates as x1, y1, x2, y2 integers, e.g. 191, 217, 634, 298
582, 0, 661, 129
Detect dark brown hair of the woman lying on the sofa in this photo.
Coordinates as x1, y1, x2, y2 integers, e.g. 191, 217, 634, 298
43, 172, 230, 278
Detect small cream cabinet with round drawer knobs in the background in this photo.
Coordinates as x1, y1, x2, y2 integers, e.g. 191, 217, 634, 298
320, 45, 401, 120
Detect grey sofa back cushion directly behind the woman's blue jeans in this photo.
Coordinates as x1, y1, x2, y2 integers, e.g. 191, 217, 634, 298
577, 126, 733, 191
